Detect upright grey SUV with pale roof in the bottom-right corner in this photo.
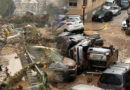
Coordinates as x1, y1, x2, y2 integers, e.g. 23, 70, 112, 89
98, 63, 130, 90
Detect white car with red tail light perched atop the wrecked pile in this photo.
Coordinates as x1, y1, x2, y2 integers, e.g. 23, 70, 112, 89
58, 15, 84, 33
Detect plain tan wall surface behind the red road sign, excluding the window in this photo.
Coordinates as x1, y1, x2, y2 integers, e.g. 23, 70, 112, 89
67, 0, 106, 20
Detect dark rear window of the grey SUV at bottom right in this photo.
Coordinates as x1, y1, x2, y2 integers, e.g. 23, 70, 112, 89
100, 74, 122, 85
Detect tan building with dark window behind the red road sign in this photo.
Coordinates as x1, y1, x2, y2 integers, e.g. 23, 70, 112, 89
67, 0, 106, 19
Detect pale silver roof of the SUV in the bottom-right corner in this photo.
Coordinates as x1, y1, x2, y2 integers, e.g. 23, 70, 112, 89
103, 63, 130, 75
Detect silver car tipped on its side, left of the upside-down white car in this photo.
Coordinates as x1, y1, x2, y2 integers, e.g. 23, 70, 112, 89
68, 39, 92, 72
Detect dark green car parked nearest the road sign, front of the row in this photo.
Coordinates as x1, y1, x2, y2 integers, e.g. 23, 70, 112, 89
92, 9, 113, 22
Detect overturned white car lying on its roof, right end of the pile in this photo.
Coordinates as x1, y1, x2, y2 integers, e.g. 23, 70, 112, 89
87, 46, 118, 68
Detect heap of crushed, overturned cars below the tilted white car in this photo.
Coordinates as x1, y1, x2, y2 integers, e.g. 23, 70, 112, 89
57, 16, 118, 72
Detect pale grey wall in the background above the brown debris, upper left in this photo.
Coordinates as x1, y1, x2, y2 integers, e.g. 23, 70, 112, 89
14, 0, 68, 16
